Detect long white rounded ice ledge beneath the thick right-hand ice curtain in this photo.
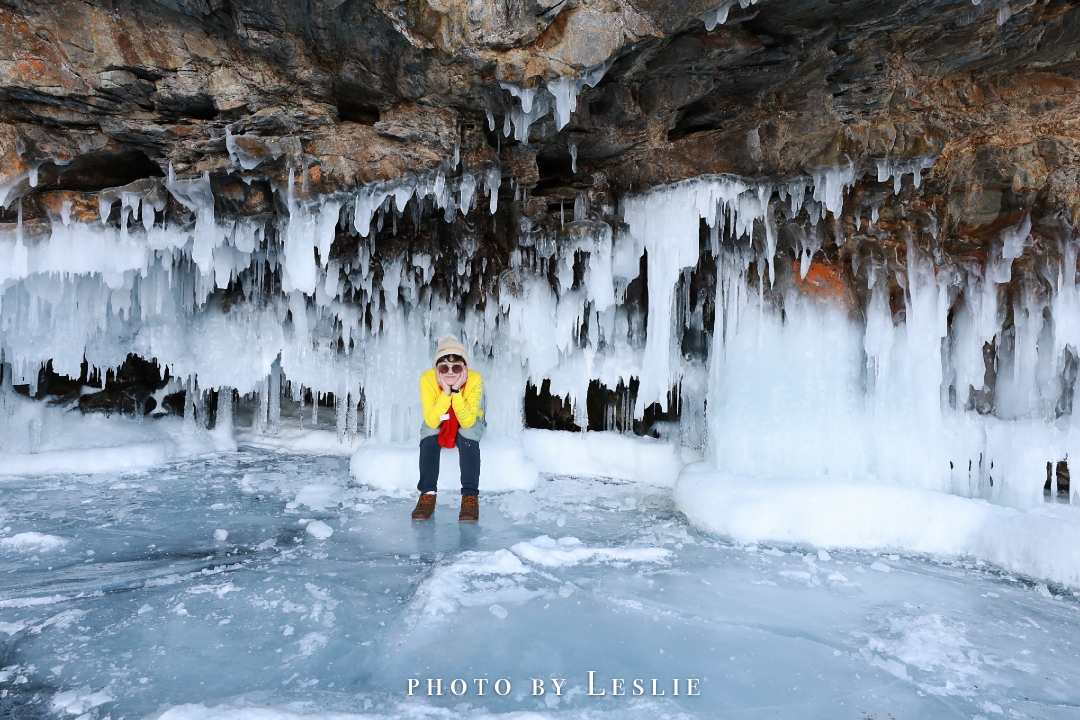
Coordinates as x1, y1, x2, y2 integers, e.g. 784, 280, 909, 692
675, 463, 1080, 587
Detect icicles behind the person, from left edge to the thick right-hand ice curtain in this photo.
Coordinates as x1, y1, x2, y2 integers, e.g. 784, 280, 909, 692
0, 154, 928, 440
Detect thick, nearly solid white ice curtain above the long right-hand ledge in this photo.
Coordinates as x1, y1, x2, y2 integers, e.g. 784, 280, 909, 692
707, 211, 1080, 508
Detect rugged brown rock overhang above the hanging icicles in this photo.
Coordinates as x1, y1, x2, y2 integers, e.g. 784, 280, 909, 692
0, 0, 1080, 284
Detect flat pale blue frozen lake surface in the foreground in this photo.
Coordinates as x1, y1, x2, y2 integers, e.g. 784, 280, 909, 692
0, 451, 1080, 720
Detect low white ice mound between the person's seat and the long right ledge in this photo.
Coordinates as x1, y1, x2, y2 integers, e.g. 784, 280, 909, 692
522, 430, 683, 487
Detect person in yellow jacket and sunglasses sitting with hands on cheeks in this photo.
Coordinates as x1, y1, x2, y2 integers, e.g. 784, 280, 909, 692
413, 335, 484, 522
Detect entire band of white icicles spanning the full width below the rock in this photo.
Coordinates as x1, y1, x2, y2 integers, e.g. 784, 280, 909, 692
0, 147, 1080, 506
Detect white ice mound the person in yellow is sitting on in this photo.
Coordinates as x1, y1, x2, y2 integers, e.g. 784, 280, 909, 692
349, 437, 538, 492
